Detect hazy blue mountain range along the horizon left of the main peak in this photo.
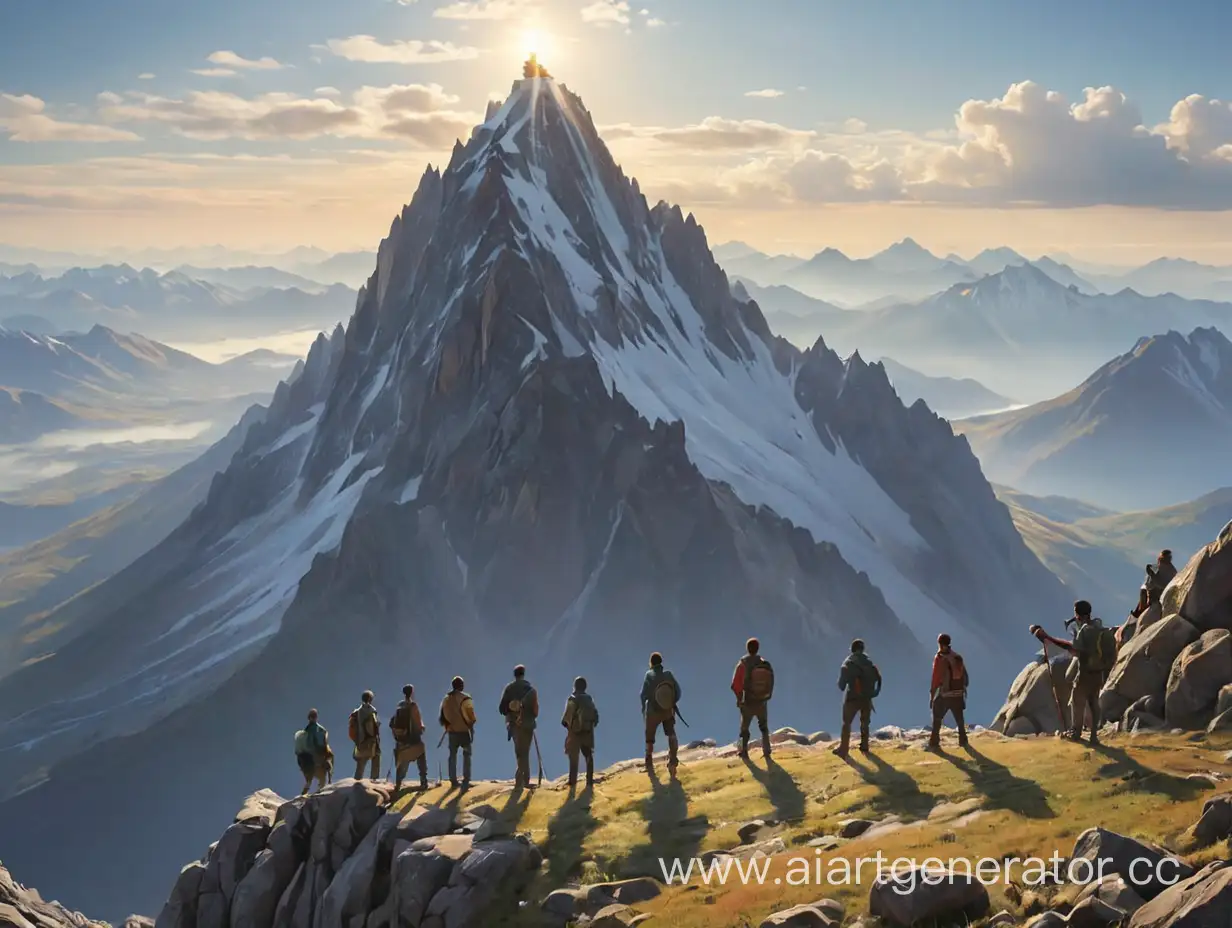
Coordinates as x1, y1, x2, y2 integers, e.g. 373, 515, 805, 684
0, 265, 356, 340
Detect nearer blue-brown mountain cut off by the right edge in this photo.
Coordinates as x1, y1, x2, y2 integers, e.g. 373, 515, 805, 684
956, 329, 1232, 510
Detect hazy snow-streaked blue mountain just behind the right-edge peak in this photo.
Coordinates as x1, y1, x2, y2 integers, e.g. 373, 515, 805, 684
827, 265, 1232, 399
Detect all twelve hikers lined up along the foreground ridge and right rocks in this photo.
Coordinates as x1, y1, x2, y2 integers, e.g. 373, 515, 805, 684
296, 551, 1177, 794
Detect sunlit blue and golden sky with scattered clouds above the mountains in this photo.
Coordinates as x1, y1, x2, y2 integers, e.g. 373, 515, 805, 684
0, 0, 1232, 264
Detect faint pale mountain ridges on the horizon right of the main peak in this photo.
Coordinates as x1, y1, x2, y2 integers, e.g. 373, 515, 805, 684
715, 238, 1232, 308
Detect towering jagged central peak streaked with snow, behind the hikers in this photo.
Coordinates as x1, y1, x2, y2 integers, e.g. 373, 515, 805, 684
0, 79, 1066, 914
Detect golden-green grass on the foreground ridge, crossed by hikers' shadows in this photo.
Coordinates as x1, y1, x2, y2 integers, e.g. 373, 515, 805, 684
389, 733, 1232, 928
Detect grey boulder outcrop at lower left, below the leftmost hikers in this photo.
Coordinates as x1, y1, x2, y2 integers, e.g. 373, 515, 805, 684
155, 780, 542, 928
